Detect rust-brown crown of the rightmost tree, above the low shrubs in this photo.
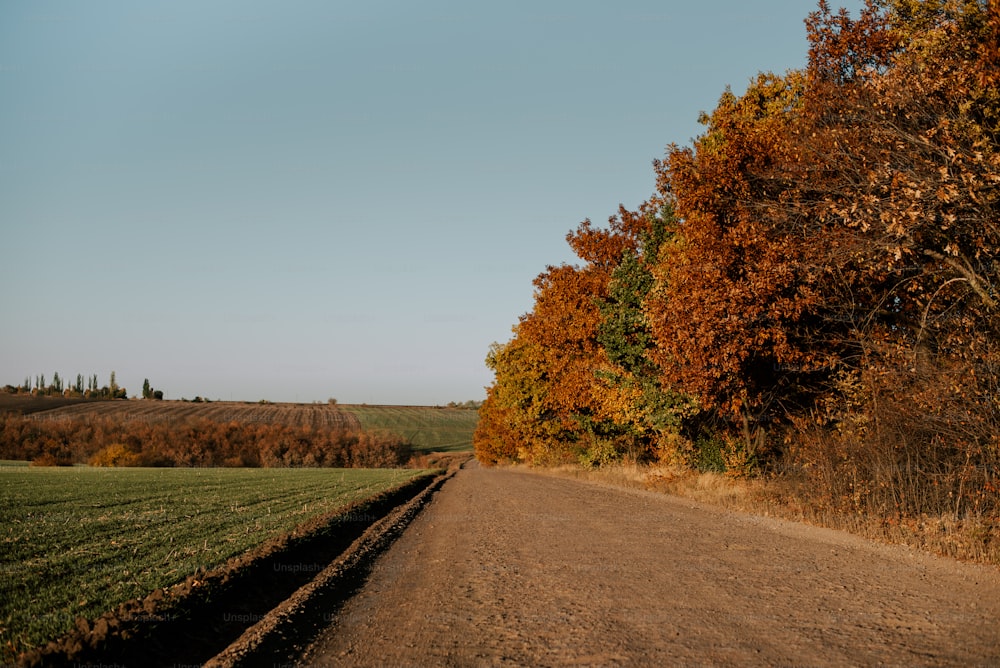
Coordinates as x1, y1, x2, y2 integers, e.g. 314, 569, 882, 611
782, 0, 1000, 357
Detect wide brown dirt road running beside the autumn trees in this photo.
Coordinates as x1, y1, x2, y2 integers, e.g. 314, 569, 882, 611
301, 466, 1000, 666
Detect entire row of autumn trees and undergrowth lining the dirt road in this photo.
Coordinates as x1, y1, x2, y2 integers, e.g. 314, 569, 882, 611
475, 0, 1000, 563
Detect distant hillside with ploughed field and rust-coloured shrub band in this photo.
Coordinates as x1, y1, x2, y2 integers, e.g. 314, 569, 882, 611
0, 395, 478, 466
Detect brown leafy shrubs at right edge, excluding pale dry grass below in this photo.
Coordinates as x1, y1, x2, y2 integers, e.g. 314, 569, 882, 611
785, 360, 1000, 520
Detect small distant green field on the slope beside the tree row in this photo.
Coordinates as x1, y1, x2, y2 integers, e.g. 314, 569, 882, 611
339, 405, 479, 452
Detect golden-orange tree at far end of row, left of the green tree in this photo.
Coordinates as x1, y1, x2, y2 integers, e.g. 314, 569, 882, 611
474, 215, 648, 463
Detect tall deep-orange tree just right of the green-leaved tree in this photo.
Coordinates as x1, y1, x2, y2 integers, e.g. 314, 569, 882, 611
646, 72, 830, 460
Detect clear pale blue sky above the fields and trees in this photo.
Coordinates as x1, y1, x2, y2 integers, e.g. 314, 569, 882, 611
0, 0, 858, 404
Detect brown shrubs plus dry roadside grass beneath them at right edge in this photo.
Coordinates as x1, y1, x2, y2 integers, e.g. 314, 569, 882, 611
770, 359, 1000, 563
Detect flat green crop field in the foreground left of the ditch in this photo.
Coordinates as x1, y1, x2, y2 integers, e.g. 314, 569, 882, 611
0, 463, 427, 660
